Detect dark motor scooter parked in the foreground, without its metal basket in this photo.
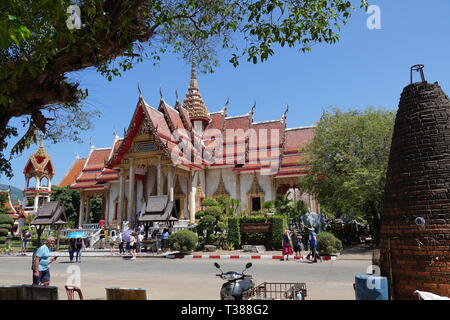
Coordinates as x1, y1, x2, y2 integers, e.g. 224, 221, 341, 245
214, 262, 255, 300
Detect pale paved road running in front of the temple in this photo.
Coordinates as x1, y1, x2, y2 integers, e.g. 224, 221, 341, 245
0, 257, 370, 300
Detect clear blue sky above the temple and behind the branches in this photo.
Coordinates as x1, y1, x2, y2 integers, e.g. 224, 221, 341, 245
0, 0, 450, 189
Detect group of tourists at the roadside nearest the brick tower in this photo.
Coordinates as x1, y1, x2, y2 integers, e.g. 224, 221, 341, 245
281, 228, 322, 263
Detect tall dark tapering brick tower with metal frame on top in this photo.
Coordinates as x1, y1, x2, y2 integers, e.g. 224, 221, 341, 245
380, 66, 450, 299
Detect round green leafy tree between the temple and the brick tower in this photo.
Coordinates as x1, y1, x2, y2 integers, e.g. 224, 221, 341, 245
300, 108, 395, 241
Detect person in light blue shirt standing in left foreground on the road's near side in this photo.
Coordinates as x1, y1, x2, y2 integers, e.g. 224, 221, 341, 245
32, 237, 58, 286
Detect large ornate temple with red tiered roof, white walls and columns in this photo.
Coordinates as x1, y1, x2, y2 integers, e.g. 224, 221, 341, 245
62, 64, 320, 226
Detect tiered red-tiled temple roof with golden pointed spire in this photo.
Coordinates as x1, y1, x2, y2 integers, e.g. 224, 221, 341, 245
66, 64, 315, 188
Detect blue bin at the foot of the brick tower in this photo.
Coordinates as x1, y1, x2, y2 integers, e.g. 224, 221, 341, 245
353, 274, 389, 300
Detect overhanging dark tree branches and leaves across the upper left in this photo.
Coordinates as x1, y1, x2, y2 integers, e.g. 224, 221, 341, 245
0, 0, 367, 176
